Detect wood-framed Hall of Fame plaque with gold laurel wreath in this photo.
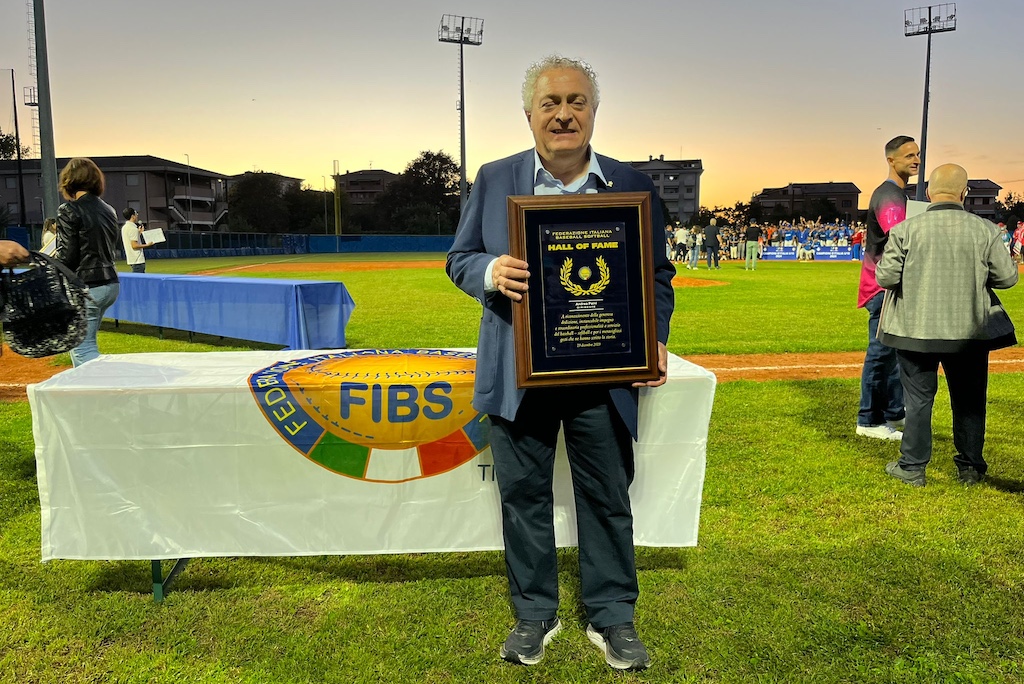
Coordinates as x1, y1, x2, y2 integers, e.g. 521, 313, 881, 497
508, 193, 658, 387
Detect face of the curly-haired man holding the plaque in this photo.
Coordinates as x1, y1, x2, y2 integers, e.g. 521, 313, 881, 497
526, 69, 597, 160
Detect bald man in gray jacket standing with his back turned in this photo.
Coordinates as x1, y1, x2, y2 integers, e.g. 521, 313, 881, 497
876, 164, 1017, 486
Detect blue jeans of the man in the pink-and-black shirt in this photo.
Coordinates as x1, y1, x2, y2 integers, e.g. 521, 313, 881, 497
857, 292, 906, 427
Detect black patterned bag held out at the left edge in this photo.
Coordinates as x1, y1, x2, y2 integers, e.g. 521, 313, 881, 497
0, 252, 89, 358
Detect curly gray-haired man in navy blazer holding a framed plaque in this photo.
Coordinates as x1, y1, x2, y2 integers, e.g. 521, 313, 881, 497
446, 55, 675, 670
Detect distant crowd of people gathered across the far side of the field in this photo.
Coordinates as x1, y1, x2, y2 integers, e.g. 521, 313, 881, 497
665, 219, 865, 269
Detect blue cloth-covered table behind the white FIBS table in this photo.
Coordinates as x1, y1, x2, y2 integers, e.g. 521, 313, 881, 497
105, 273, 355, 349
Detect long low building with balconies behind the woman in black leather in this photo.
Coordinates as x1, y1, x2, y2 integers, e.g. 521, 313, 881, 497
0, 155, 227, 230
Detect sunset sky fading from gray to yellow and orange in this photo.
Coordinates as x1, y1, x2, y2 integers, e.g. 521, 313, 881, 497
0, 0, 1024, 207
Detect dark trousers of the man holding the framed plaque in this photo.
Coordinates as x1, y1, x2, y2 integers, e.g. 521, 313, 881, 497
490, 386, 639, 628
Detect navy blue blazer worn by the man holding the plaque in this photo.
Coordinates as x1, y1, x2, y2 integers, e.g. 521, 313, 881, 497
445, 149, 676, 439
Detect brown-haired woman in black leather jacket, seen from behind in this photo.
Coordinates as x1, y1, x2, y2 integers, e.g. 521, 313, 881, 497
53, 157, 120, 366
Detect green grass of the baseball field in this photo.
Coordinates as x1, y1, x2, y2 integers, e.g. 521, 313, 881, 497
0, 255, 1024, 683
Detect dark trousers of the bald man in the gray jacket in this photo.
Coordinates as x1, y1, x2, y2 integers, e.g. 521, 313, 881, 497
896, 349, 988, 474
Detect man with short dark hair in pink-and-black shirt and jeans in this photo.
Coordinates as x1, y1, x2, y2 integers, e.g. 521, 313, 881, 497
857, 135, 921, 440
